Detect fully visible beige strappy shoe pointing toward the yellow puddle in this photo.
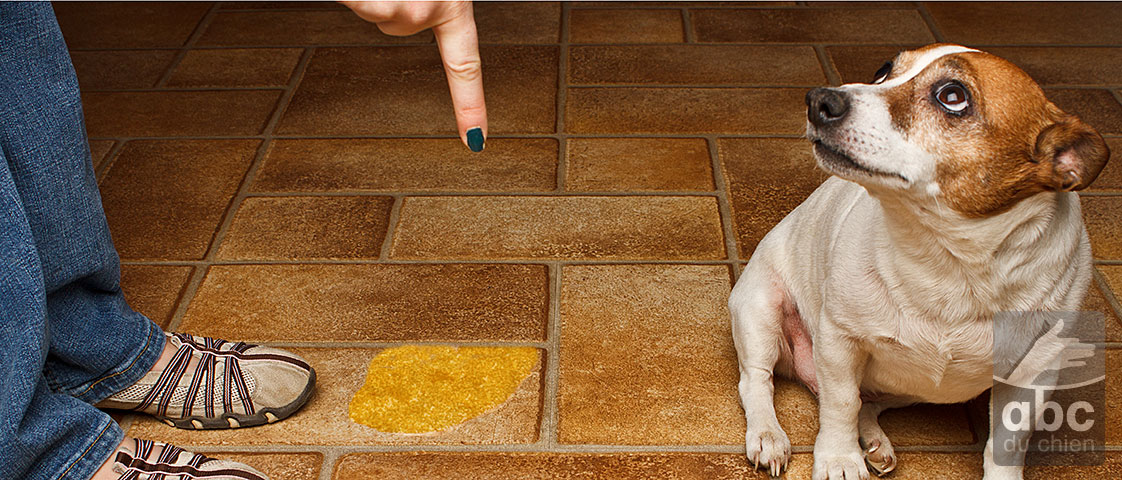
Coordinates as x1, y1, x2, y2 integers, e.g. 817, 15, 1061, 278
98, 333, 315, 430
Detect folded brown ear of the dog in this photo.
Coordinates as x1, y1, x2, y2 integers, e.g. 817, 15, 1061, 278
1032, 114, 1111, 192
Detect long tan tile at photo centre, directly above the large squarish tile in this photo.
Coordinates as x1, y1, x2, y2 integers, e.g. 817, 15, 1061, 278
390, 196, 725, 260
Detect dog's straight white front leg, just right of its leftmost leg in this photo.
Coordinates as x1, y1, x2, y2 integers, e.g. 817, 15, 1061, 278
813, 327, 868, 480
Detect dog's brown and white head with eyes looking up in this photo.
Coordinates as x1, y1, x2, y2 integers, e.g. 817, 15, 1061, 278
807, 44, 1110, 216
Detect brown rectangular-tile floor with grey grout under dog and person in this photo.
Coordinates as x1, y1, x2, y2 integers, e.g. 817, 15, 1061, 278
56, 2, 1122, 480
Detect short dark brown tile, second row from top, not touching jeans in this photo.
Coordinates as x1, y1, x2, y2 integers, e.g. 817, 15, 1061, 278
167, 48, 303, 86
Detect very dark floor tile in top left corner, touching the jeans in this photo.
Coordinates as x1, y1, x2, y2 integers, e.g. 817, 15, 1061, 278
53, 1, 212, 48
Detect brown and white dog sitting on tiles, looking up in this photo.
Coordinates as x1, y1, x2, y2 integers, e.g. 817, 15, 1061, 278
728, 44, 1110, 480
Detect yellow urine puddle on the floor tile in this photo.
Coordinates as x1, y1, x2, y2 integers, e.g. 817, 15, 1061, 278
350, 345, 539, 433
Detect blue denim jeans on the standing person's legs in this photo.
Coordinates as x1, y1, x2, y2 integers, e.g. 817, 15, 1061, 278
0, 2, 164, 480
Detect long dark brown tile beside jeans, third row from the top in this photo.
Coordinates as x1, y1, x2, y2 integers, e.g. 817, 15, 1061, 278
82, 90, 281, 137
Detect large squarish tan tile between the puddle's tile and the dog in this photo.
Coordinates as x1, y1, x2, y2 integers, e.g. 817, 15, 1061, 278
558, 265, 745, 445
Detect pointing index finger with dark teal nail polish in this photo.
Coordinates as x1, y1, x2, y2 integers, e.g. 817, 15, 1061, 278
432, 4, 487, 151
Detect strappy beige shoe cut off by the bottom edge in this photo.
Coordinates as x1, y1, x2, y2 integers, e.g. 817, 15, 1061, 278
110, 439, 268, 480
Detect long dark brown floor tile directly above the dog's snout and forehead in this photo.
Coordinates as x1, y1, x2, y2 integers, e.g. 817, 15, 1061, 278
690, 8, 935, 44
